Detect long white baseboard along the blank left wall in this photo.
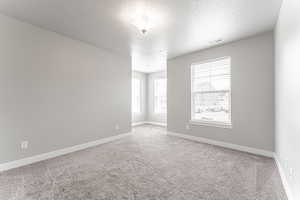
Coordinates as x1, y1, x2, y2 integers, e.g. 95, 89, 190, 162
0, 133, 131, 172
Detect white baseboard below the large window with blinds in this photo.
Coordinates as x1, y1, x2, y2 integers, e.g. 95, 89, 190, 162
167, 131, 274, 158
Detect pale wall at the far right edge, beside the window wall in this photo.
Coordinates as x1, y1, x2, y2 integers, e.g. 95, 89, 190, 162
275, 0, 300, 200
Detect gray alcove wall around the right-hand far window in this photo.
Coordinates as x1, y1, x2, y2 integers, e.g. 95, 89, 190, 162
147, 71, 167, 124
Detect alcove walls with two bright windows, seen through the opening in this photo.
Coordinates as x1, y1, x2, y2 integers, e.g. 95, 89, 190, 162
131, 71, 167, 127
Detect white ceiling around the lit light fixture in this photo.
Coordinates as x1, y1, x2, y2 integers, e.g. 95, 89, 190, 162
0, 0, 282, 72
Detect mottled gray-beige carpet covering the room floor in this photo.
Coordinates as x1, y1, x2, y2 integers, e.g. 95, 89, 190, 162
0, 126, 287, 200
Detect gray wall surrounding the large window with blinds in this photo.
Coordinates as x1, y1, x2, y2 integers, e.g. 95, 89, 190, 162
167, 32, 274, 151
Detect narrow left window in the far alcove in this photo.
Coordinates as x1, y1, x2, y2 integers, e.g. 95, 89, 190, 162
132, 78, 141, 113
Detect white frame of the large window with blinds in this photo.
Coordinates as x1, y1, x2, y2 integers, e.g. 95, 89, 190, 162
190, 56, 232, 128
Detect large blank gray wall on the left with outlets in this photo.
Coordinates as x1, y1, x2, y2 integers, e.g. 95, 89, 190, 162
0, 15, 131, 163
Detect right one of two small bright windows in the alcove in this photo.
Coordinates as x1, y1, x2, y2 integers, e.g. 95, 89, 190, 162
154, 78, 167, 114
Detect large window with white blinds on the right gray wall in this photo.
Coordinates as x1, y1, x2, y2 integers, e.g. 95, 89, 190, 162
191, 58, 231, 126
